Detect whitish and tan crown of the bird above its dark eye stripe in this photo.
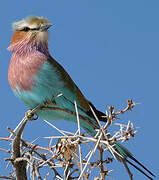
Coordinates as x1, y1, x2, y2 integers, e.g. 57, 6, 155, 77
13, 16, 48, 31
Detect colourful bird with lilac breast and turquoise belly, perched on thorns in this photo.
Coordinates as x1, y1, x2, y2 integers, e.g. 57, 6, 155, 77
8, 16, 155, 180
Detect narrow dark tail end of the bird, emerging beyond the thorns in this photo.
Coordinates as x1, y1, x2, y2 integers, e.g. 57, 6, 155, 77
115, 142, 155, 180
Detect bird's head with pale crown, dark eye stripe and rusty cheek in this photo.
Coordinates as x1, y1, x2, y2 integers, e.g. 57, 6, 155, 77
8, 16, 52, 50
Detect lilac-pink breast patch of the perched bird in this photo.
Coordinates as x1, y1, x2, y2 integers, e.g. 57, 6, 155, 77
8, 51, 47, 91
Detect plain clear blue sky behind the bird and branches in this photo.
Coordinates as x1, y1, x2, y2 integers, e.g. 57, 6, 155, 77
0, 0, 159, 180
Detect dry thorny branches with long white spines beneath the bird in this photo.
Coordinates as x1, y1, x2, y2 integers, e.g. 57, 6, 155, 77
0, 100, 136, 180
